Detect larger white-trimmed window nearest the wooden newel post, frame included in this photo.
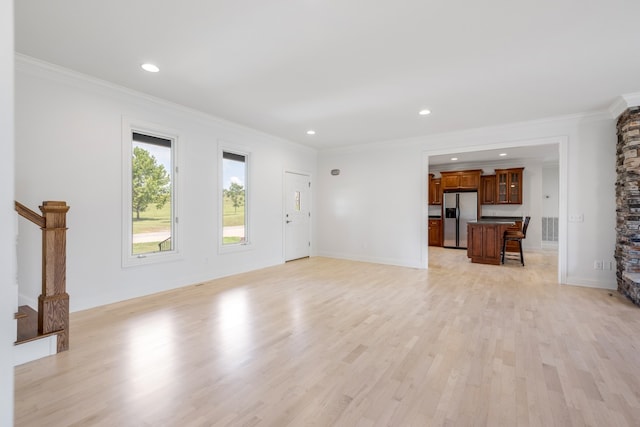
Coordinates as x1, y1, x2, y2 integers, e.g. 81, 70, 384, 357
123, 118, 178, 266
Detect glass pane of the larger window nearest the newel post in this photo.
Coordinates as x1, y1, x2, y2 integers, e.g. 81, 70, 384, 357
131, 132, 174, 255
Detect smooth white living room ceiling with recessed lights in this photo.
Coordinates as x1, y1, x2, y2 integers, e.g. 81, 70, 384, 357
15, 0, 640, 149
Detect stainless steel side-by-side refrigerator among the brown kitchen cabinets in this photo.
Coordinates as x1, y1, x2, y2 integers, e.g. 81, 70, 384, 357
443, 191, 478, 249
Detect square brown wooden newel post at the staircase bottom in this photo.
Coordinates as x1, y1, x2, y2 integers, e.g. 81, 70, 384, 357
38, 201, 69, 352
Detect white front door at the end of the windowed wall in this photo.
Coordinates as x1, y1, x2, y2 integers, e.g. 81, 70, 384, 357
284, 172, 311, 261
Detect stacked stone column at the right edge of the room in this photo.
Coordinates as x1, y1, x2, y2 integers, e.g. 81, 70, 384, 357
615, 107, 640, 306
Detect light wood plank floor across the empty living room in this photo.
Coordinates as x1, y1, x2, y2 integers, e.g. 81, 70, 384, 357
15, 248, 640, 426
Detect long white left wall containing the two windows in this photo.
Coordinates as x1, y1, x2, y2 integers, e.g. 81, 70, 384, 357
16, 57, 316, 311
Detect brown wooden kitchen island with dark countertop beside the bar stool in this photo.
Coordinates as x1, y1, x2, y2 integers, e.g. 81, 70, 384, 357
467, 219, 515, 265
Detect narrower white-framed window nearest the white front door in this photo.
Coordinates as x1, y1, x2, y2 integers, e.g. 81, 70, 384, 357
220, 149, 249, 247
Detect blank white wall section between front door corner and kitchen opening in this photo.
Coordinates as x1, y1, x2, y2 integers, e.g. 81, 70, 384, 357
316, 146, 427, 267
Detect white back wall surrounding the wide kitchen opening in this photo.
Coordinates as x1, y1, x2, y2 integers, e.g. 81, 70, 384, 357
317, 113, 616, 289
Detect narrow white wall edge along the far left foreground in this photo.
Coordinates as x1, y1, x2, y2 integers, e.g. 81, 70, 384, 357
0, 0, 18, 426
